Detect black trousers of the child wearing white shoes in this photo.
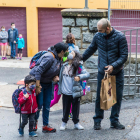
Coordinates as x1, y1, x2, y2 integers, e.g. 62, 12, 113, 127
62, 94, 81, 124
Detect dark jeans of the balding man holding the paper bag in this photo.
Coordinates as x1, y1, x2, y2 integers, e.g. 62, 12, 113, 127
93, 70, 124, 123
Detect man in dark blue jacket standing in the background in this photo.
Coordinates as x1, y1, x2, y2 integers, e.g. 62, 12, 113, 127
8, 23, 18, 59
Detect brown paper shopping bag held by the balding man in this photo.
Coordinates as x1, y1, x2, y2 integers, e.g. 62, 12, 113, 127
100, 73, 117, 110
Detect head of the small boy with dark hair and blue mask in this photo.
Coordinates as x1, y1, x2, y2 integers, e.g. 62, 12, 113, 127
24, 75, 36, 90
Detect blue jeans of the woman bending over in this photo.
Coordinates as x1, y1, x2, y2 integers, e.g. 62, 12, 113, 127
35, 83, 52, 126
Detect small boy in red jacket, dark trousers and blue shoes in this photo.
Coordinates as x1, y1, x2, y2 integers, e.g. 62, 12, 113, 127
18, 75, 38, 137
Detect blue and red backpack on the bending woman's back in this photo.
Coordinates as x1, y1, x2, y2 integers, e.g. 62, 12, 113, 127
29, 51, 48, 69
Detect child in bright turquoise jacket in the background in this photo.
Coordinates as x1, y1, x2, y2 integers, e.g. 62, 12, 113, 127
16, 34, 25, 60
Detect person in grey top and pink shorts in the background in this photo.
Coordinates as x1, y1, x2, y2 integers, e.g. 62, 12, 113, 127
0, 26, 8, 60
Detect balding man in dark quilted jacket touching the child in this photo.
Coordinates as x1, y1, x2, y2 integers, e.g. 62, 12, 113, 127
83, 19, 128, 130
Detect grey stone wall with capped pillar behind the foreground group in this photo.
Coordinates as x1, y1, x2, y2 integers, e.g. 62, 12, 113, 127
61, 9, 140, 102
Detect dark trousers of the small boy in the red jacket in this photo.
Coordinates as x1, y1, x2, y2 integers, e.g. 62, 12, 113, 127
21, 113, 35, 132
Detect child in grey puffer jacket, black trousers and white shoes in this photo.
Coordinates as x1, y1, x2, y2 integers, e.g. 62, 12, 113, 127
58, 51, 90, 130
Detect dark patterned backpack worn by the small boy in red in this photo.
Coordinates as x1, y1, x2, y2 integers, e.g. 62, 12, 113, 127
12, 87, 25, 113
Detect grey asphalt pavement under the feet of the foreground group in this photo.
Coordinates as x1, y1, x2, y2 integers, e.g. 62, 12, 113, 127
0, 99, 140, 140
